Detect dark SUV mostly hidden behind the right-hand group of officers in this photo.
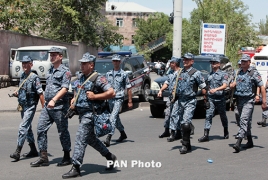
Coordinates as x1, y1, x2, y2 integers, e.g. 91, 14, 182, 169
148, 56, 231, 117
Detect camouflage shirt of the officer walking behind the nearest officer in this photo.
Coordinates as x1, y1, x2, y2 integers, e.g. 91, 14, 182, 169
106, 69, 131, 98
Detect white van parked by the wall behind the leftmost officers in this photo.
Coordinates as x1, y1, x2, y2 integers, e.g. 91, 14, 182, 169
10, 45, 69, 84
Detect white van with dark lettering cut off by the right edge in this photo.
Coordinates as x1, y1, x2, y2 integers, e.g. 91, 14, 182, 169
251, 46, 268, 85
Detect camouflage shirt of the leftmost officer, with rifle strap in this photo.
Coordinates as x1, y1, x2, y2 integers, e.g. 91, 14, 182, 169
18, 72, 43, 106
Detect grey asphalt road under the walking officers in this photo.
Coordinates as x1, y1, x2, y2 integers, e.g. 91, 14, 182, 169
0, 105, 268, 180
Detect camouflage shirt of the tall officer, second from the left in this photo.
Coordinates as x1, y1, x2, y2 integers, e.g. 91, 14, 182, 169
45, 64, 72, 109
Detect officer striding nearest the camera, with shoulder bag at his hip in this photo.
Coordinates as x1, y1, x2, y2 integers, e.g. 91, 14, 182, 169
62, 53, 116, 179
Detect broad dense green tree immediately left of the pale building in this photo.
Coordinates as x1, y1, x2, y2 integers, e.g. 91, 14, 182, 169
37, 0, 123, 47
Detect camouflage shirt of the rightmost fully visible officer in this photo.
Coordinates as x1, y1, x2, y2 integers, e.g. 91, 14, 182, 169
234, 67, 263, 98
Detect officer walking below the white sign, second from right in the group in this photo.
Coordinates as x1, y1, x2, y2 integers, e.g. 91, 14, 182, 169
198, 56, 229, 142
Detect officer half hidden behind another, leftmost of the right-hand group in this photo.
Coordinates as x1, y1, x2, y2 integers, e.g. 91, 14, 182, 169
157, 57, 181, 142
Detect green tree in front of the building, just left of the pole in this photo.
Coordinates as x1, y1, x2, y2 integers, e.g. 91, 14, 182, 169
134, 13, 173, 59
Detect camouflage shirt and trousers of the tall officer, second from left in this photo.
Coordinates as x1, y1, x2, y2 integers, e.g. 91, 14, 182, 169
37, 64, 72, 151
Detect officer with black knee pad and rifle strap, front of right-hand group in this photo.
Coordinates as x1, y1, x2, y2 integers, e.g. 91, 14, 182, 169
176, 53, 206, 154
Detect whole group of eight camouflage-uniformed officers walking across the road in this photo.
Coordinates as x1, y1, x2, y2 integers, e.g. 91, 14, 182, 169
10, 47, 266, 178
